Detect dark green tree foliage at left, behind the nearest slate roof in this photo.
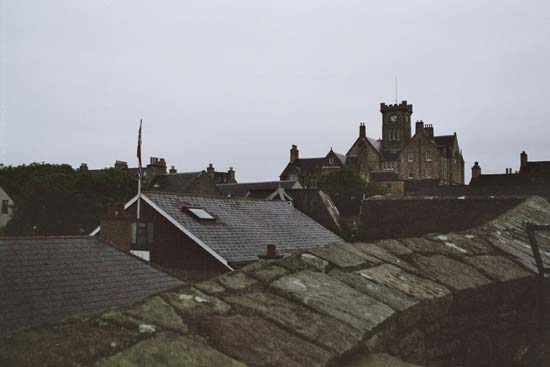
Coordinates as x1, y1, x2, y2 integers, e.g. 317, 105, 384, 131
0, 163, 137, 235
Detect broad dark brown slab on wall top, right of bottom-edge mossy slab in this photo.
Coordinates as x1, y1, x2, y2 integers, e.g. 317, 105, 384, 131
200, 315, 334, 367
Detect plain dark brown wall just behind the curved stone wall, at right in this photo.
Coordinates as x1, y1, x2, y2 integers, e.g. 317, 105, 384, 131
356, 197, 523, 241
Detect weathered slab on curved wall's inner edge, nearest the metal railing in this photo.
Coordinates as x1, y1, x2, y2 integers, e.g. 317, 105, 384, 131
464, 255, 534, 282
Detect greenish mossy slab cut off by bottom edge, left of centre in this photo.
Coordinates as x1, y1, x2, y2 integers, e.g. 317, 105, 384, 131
96, 335, 246, 367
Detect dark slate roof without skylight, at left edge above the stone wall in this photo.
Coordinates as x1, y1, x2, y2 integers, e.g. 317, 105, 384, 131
0, 236, 182, 335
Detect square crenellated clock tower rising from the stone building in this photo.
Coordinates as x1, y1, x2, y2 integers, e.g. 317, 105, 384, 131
380, 101, 413, 152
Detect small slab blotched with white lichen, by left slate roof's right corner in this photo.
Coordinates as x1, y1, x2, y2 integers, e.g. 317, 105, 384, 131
163, 288, 231, 317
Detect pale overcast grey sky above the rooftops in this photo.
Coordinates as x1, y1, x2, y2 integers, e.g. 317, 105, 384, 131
0, 0, 550, 181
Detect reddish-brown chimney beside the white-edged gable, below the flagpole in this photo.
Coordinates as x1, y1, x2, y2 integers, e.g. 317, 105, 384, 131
100, 204, 131, 251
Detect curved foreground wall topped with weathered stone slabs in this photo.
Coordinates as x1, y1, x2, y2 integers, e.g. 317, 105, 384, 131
0, 198, 550, 367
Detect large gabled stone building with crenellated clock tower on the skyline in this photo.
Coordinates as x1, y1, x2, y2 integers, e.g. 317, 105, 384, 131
280, 101, 464, 187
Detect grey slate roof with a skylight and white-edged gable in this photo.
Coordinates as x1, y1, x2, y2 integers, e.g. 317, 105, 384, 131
144, 192, 341, 263
